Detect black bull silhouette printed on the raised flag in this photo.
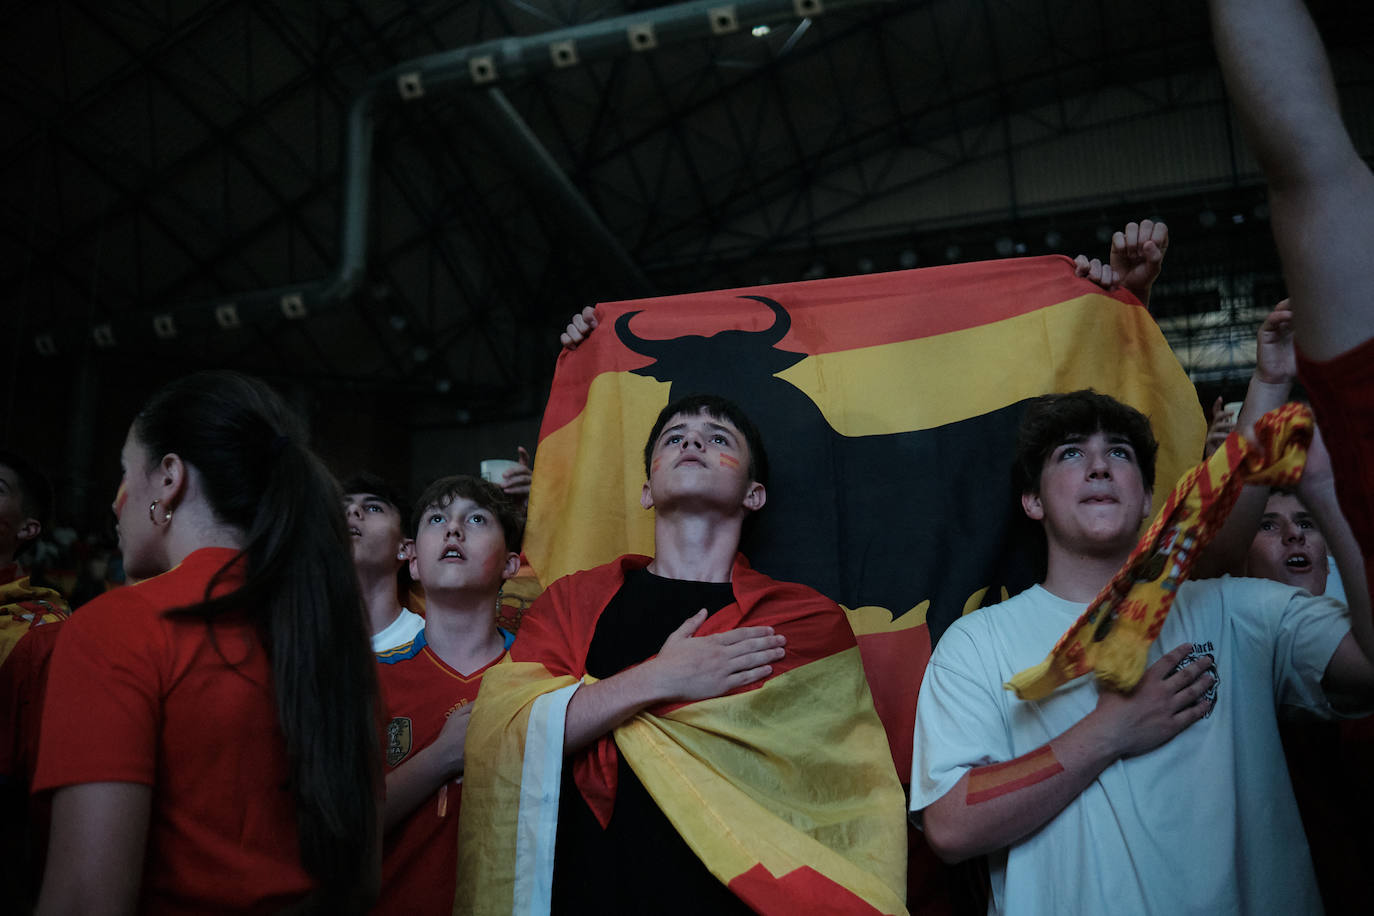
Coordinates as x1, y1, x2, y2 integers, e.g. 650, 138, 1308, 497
616, 295, 1043, 644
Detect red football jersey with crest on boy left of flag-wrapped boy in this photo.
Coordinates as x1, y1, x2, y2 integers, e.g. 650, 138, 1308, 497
372, 630, 515, 916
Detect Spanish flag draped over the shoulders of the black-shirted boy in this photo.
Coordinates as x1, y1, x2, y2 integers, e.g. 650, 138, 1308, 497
453, 556, 905, 916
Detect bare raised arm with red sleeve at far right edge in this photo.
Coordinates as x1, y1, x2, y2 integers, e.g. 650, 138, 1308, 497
1210, 0, 1374, 645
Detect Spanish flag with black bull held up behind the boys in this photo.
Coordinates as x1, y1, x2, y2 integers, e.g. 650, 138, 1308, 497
525, 255, 1205, 773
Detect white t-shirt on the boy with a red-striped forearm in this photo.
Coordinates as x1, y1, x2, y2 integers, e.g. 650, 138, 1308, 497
911, 577, 1349, 916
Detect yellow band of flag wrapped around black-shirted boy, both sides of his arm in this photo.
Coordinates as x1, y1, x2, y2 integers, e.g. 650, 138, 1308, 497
453, 648, 907, 913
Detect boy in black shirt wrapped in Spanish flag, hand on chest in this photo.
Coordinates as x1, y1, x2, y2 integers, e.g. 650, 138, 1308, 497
459, 396, 905, 913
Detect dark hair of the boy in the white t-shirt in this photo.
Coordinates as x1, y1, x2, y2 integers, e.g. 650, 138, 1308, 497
1014, 389, 1160, 493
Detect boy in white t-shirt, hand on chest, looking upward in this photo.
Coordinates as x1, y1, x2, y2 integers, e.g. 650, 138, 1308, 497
911, 391, 1374, 913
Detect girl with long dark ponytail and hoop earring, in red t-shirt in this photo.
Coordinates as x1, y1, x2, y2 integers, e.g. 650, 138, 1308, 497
34, 372, 382, 913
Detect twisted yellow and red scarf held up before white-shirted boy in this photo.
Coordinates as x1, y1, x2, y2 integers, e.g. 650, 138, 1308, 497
1004, 404, 1314, 700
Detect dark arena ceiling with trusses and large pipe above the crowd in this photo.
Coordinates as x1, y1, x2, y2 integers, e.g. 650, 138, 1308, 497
0, 0, 1374, 519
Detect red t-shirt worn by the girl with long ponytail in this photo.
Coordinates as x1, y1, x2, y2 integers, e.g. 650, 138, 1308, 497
34, 548, 312, 913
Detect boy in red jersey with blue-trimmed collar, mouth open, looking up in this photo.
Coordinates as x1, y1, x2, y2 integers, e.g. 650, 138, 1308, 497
374, 477, 522, 915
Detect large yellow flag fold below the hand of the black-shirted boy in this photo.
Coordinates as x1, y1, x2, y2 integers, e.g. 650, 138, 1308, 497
616, 648, 907, 913
